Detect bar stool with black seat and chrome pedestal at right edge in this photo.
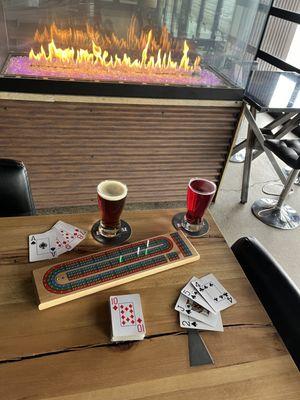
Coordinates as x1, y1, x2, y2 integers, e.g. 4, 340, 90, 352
251, 139, 300, 229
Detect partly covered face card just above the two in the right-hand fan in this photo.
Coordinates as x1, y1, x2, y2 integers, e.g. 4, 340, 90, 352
175, 294, 217, 326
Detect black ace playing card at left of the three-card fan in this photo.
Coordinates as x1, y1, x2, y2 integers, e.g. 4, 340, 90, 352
29, 229, 60, 262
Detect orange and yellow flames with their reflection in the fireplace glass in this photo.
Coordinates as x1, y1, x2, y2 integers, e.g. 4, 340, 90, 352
29, 17, 201, 73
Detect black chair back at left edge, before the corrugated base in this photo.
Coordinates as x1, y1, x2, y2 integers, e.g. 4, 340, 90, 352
0, 158, 36, 217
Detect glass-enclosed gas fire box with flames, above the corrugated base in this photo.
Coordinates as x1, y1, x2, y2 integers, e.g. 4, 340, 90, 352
0, 0, 271, 100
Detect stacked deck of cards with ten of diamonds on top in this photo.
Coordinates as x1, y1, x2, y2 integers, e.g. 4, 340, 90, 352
109, 294, 146, 342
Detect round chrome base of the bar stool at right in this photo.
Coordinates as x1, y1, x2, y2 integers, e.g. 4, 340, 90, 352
251, 199, 300, 229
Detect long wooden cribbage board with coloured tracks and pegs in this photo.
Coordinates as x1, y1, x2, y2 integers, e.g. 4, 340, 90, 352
33, 231, 200, 310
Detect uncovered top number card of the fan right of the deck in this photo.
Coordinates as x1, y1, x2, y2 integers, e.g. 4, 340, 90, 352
192, 274, 236, 312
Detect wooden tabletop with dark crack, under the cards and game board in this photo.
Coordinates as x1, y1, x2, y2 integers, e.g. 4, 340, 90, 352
0, 209, 300, 400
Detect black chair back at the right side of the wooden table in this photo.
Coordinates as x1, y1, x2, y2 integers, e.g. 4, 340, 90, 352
232, 237, 300, 370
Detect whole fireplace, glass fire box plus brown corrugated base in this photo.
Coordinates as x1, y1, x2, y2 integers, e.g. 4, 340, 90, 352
0, 0, 271, 208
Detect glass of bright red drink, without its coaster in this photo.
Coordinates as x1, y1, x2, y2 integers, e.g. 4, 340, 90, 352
184, 178, 216, 230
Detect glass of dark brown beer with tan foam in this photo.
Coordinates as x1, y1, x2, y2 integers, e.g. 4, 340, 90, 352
97, 180, 127, 238
